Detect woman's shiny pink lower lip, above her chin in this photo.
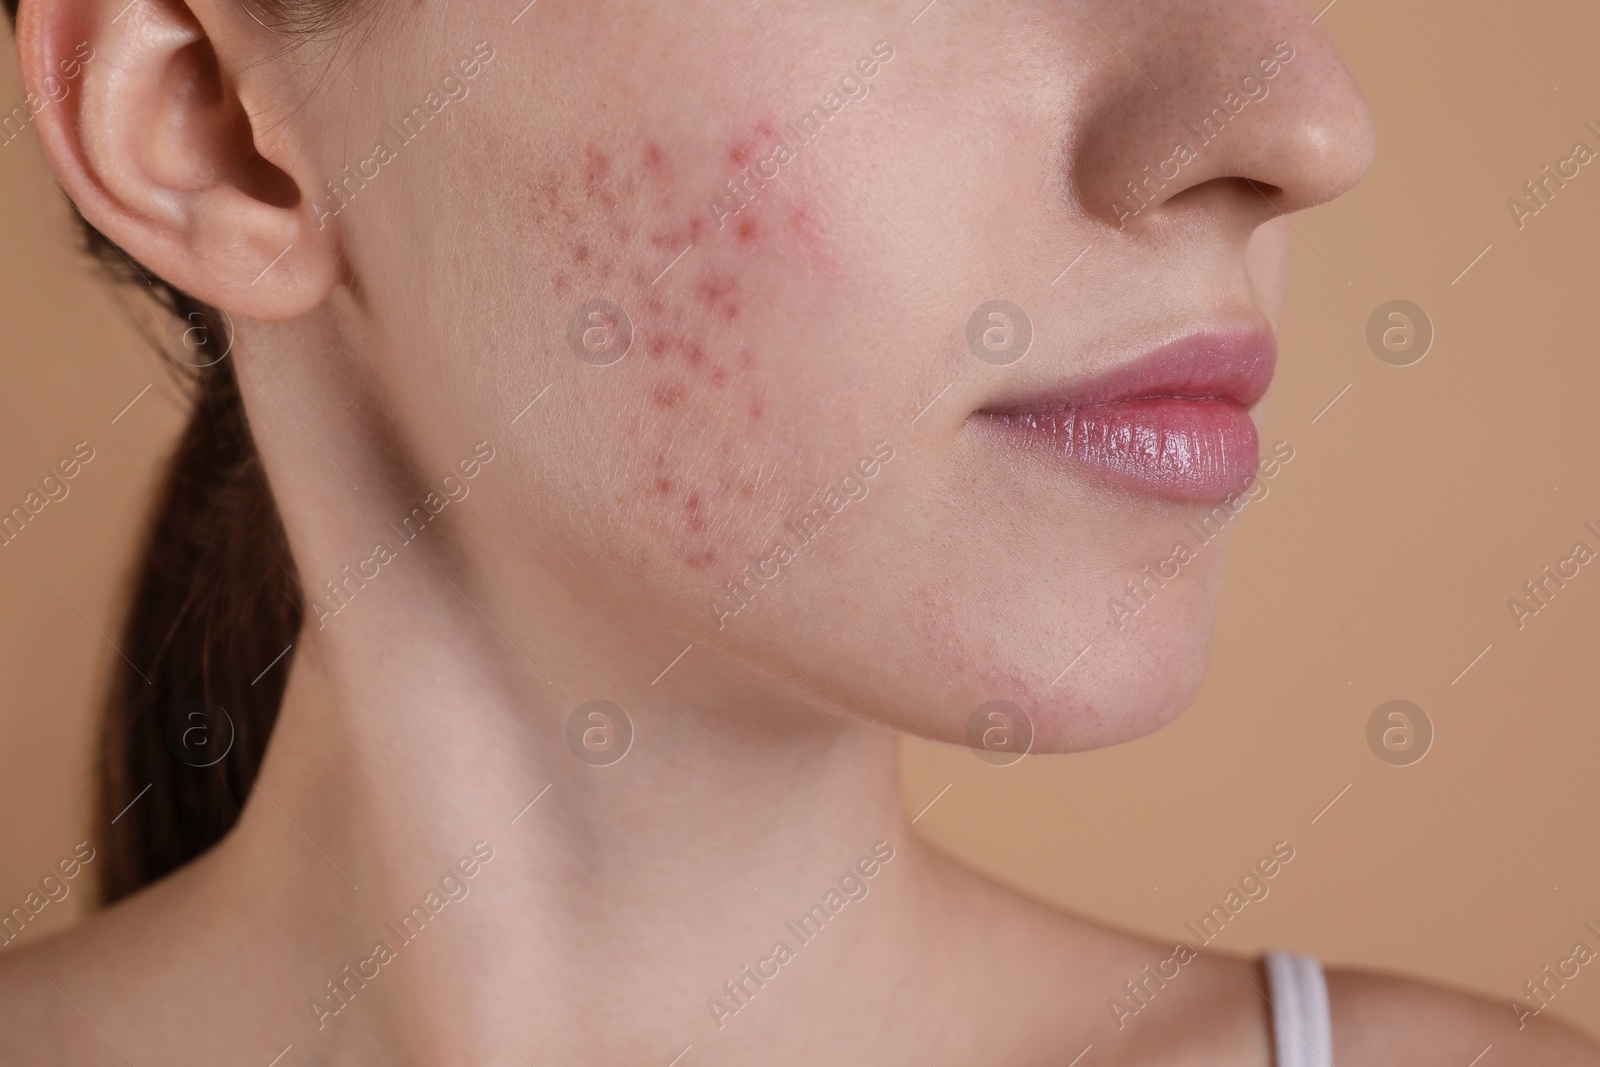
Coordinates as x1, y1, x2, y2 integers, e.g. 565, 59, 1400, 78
986, 397, 1261, 501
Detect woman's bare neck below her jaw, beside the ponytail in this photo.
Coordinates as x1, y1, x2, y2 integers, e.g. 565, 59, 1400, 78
216, 549, 938, 1062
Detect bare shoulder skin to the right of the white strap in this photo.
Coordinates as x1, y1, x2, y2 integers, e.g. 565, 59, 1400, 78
1328, 968, 1600, 1067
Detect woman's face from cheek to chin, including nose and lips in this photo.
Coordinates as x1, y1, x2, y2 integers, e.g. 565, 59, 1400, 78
278, 0, 1373, 750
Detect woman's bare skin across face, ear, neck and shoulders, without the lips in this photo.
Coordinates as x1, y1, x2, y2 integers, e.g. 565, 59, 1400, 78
0, 0, 1600, 1067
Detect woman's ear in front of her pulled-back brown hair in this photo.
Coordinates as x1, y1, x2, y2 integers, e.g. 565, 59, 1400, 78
18, 0, 341, 320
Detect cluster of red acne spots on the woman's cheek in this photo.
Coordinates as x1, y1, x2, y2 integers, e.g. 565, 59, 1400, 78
530, 123, 826, 571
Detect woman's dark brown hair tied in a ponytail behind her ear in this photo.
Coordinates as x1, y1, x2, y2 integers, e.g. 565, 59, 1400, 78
3, 0, 352, 904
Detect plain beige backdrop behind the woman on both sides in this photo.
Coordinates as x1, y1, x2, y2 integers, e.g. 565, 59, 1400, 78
9, 0, 1600, 1032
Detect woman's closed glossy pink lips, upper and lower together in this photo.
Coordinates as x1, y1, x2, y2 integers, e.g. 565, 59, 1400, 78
978, 331, 1277, 501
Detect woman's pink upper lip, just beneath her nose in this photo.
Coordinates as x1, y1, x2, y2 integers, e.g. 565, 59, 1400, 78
979, 330, 1277, 416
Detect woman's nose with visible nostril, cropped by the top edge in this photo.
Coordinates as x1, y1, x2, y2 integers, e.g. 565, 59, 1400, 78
1066, 0, 1376, 234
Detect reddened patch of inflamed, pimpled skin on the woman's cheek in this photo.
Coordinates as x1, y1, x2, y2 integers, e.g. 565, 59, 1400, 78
531, 120, 838, 571
